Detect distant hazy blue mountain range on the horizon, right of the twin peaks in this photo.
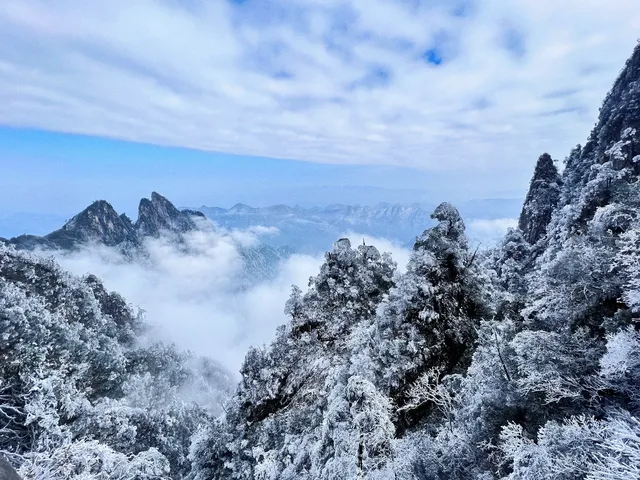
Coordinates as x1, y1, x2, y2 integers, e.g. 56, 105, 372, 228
197, 199, 520, 254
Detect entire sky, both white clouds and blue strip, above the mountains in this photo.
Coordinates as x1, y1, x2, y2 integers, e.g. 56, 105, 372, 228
0, 0, 640, 216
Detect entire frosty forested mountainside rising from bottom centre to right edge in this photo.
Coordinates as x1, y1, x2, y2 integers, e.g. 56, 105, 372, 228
192, 45, 640, 480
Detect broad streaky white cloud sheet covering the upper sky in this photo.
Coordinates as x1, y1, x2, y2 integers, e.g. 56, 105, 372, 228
0, 0, 640, 173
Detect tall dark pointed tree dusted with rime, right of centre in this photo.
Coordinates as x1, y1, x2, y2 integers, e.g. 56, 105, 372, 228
375, 203, 489, 428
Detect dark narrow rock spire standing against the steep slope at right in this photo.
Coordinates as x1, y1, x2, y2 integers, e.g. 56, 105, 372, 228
518, 153, 562, 244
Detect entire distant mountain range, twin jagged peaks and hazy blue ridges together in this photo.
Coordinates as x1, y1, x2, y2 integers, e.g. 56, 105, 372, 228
0, 196, 521, 254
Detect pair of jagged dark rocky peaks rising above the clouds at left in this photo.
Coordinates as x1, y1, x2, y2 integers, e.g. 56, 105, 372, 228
8, 192, 204, 250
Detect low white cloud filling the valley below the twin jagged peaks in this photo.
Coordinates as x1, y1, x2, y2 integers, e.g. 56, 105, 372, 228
41, 231, 322, 372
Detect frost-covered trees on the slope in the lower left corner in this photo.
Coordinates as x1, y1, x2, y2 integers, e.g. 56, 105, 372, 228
0, 246, 230, 479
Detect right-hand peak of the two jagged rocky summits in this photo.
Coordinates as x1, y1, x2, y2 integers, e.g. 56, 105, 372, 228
135, 192, 197, 237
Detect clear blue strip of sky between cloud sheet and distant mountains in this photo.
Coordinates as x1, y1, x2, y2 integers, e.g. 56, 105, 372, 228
0, 127, 529, 218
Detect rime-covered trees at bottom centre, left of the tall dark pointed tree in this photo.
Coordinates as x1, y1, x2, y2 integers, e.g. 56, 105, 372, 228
200, 239, 395, 479
